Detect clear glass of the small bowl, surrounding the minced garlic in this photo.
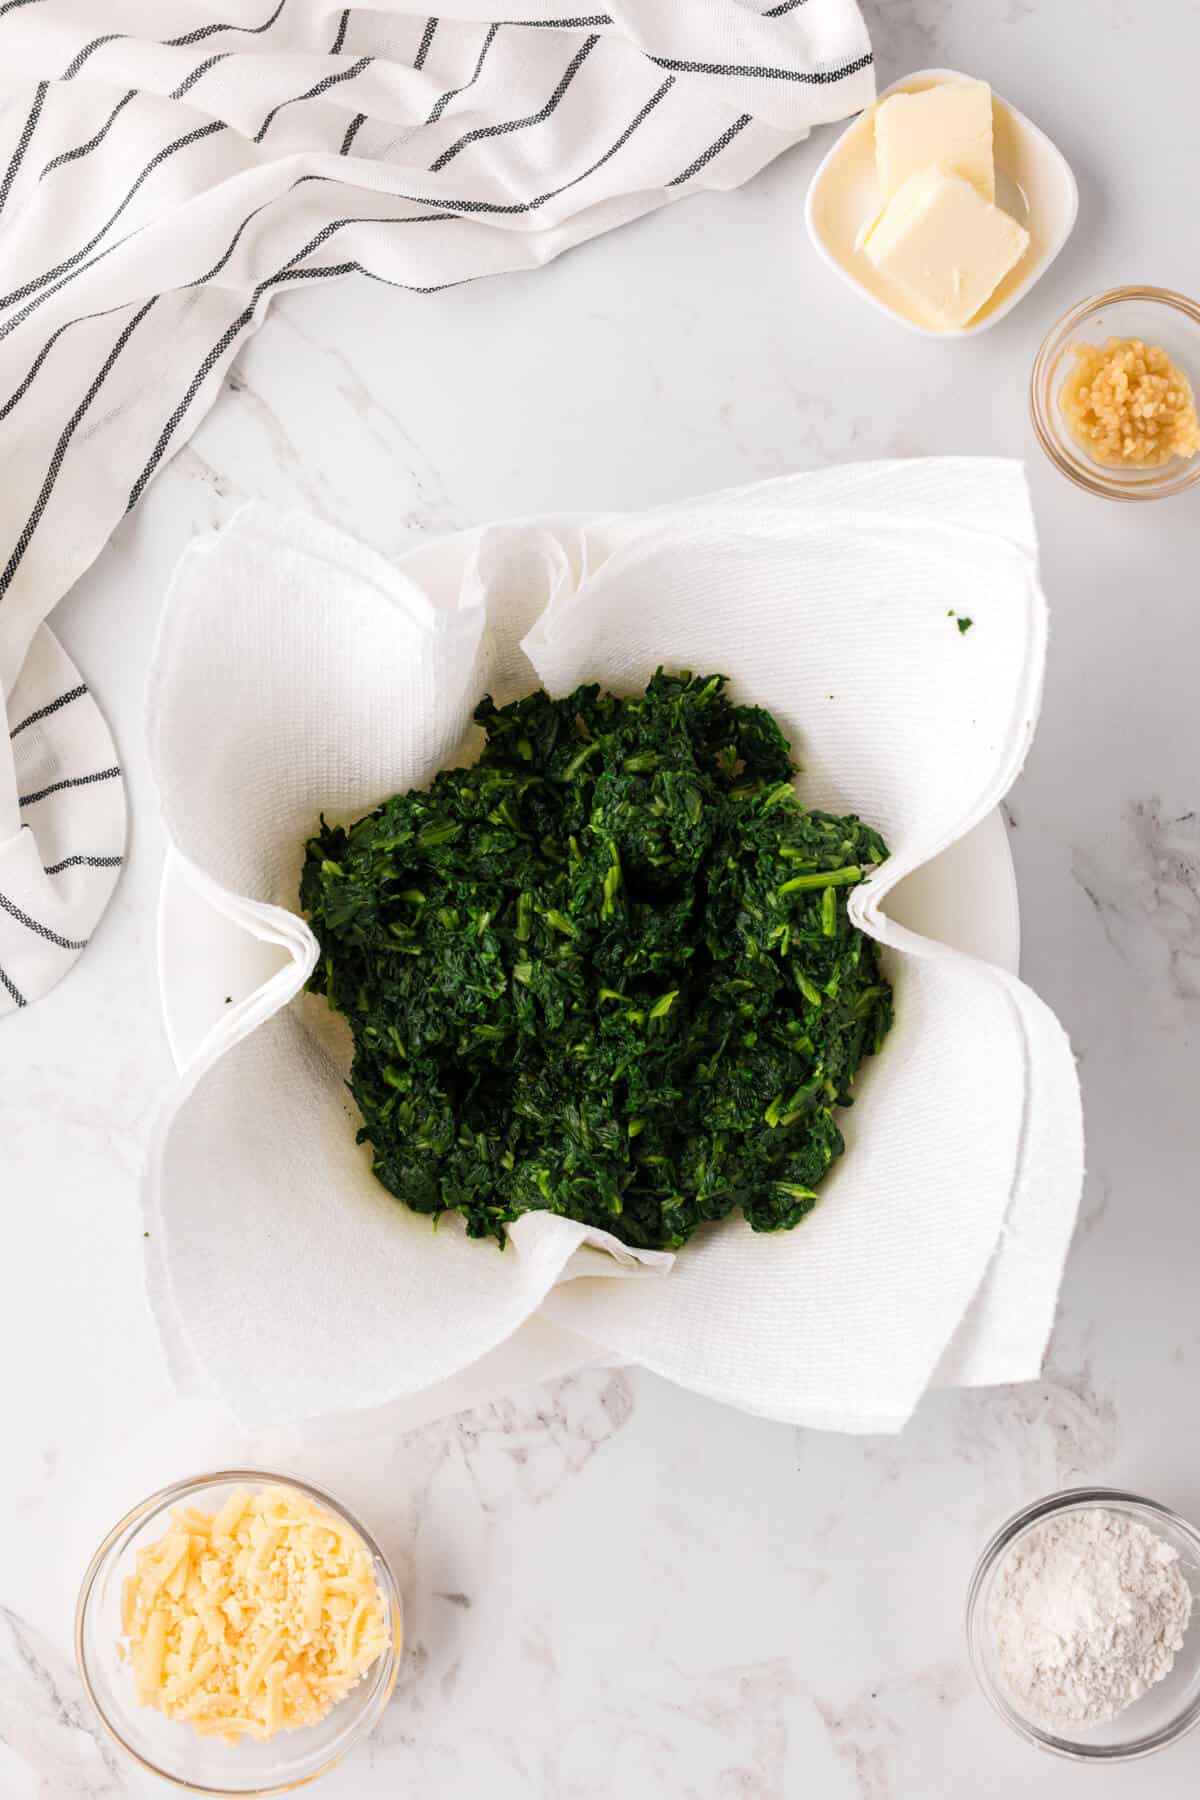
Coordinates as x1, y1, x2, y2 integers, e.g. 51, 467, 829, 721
1029, 288, 1200, 500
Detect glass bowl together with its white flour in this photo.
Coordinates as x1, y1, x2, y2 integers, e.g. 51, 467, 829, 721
966, 1487, 1200, 1762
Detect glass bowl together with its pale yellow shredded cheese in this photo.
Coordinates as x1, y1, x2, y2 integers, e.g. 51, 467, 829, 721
76, 1469, 401, 1796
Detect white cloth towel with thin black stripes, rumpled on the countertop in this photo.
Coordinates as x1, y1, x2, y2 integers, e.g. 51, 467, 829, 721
0, 0, 874, 1012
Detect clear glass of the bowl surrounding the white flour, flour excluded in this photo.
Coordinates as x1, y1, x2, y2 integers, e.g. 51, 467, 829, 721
966, 1487, 1200, 1762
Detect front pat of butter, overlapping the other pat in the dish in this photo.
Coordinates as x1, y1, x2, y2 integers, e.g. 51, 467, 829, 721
864, 169, 1029, 331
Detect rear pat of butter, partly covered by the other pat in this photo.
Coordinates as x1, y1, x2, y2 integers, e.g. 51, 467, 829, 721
874, 81, 997, 203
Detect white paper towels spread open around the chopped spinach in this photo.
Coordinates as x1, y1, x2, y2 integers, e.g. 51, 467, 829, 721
148, 461, 1081, 1431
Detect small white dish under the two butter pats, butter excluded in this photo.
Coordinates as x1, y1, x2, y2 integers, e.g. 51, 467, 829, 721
804, 68, 1079, 338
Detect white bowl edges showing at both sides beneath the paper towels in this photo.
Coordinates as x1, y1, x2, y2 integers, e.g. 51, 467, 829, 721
158, 812, 1020, 1069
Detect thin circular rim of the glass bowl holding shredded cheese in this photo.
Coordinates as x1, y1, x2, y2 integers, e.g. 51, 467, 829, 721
74, 1469, 403, 1800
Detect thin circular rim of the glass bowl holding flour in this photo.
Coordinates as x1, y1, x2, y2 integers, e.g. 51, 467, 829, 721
966, 1487, 1200, 1762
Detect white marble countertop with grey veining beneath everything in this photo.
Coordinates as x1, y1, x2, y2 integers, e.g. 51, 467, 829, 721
0, 0, 1200, 1800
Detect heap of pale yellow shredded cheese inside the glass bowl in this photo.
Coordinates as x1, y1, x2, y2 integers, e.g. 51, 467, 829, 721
121, 1487, 390, 1742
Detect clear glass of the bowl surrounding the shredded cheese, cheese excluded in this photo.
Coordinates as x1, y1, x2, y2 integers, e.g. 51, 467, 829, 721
76, 1469, 403, 1800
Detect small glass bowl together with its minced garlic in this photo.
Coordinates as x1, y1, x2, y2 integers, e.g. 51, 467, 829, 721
1029, 288, 1200, 500
